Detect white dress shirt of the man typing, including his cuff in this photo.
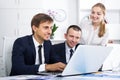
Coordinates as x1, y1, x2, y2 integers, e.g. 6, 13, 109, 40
33, 37, 45, 72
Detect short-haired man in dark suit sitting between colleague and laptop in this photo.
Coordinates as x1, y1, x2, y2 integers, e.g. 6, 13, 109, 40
50, 25, 82, 64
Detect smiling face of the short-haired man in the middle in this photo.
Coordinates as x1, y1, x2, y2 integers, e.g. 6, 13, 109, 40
65, 28, 81, 48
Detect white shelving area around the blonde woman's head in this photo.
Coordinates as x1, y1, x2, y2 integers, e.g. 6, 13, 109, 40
78, 0, 120, 43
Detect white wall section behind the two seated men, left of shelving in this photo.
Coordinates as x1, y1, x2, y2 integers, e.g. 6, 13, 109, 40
0, 0, 77, 56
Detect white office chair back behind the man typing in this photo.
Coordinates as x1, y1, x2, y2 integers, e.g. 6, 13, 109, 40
3, 37, 17, 76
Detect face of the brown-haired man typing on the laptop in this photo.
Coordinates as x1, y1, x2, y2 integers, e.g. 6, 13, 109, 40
33, 22, 53, 43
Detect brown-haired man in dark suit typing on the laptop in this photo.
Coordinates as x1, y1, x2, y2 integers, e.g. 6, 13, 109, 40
10, 13, 65, 75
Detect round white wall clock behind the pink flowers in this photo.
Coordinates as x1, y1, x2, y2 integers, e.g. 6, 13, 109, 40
54, 9, 66, 22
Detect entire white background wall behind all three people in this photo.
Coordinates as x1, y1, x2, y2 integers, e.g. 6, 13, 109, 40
0, 0, 120, 76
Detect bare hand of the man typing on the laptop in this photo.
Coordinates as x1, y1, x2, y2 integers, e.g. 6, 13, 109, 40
45, 62, 66, 71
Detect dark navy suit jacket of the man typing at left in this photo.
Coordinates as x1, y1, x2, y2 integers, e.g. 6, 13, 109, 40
10, 35, 51, 75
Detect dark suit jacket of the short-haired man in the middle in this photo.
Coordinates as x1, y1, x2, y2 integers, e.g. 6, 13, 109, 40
50, 42, 79, 64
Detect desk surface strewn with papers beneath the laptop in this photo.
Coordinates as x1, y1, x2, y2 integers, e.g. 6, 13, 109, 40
0, 72, 120, 80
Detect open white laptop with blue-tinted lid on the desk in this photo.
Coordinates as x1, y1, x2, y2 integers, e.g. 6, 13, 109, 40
37, 45, 112, 76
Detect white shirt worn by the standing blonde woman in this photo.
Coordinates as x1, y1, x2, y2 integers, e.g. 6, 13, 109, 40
80, 21, 108, 45
